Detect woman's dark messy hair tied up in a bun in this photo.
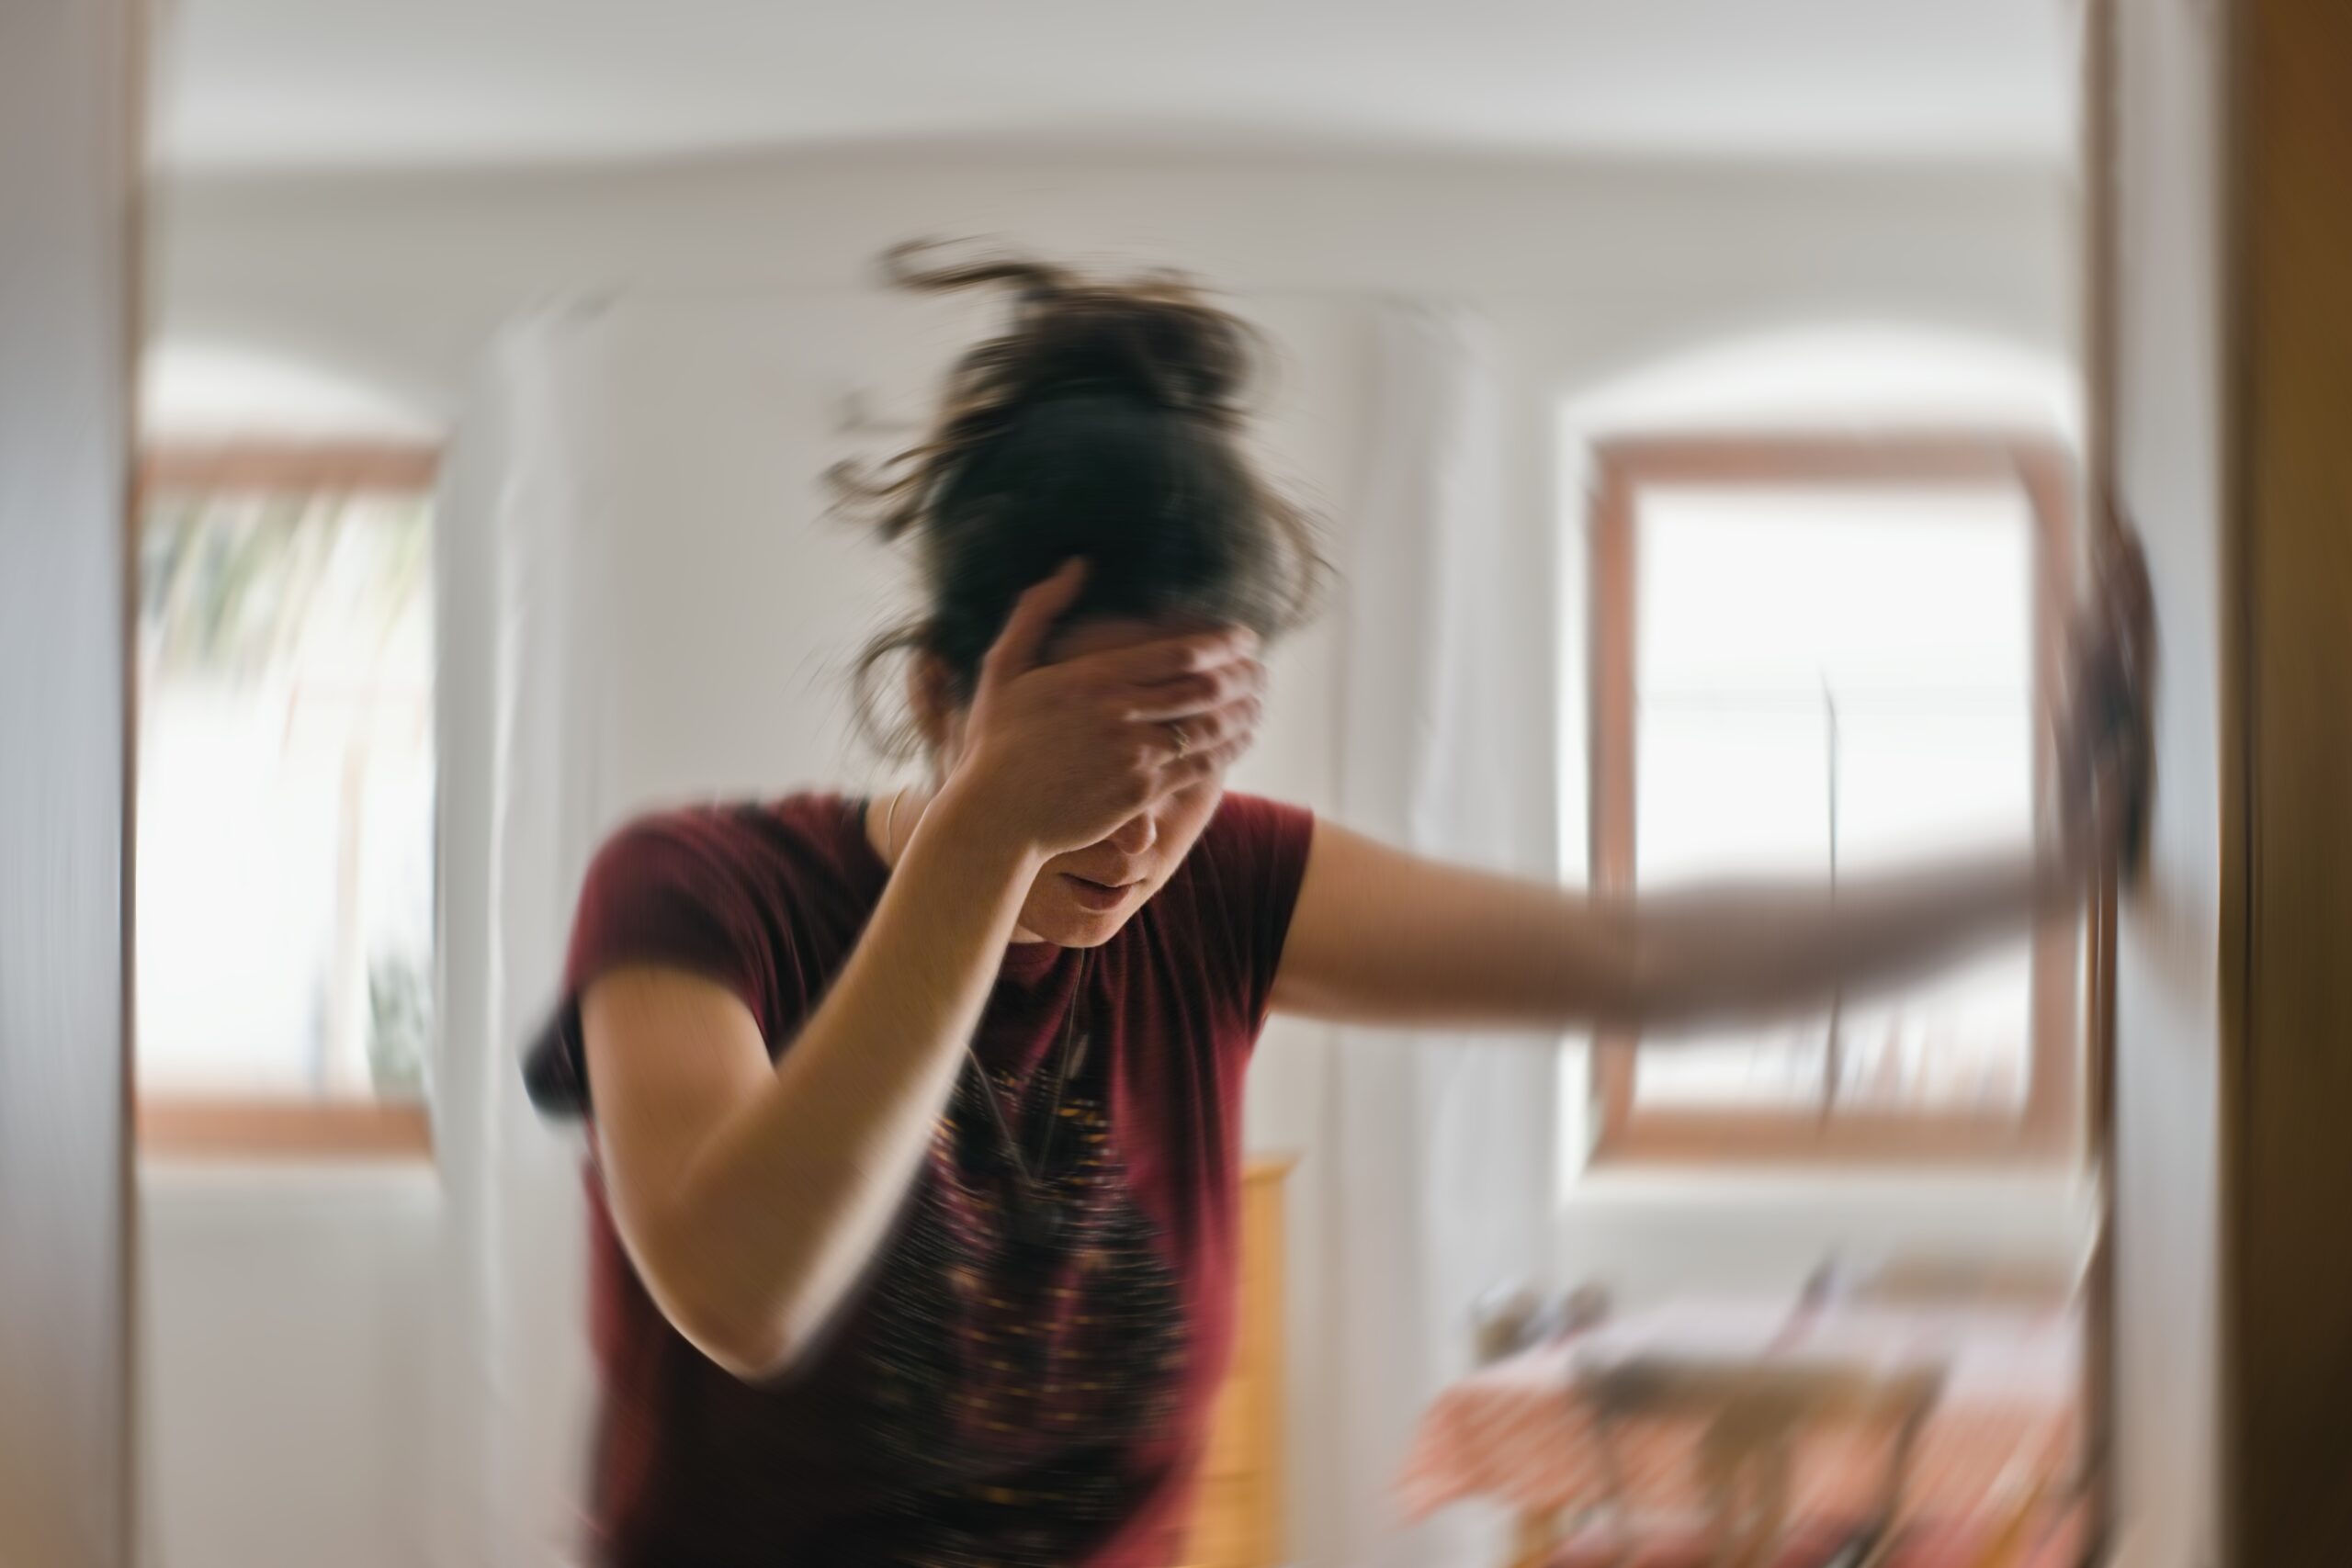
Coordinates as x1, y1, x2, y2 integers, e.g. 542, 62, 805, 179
831, 243, 1324, 757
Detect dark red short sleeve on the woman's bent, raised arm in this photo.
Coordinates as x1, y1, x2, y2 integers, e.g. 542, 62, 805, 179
525, 811, 776, 1114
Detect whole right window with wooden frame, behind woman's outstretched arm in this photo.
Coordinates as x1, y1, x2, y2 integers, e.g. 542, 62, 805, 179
1590, 440, 2079, 1159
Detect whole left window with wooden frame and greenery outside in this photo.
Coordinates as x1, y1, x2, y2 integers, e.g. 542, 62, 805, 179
136, 446, 435, 1155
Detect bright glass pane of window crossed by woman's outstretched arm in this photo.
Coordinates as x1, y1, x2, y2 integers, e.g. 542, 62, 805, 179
1634, 487, 2037, 1112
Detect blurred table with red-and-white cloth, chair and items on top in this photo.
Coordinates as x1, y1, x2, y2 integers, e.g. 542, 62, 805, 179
1397, 1267, 2082, 1568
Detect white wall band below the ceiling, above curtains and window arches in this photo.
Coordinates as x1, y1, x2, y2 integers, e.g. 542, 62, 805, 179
155, 148, 2072, 425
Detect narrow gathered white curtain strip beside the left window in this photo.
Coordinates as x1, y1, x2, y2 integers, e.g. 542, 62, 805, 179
425, 310, 600, 1568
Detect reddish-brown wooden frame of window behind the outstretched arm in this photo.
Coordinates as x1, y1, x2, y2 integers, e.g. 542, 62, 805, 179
1588, 433, 2082, 1164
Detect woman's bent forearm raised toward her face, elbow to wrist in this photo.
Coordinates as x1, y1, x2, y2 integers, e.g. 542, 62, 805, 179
656, 795, 1035, 1373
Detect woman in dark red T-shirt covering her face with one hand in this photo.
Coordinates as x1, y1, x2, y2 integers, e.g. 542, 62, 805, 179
532, 254, 2138, 1568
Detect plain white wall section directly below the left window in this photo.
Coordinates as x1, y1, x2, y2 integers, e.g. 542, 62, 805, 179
139, 1166, 440, 1568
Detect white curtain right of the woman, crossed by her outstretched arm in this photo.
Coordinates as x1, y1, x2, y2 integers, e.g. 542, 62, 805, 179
1324, 306, 1559, 1568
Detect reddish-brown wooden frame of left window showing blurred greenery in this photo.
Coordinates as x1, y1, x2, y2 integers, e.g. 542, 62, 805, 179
130, 440, 442, 1164
